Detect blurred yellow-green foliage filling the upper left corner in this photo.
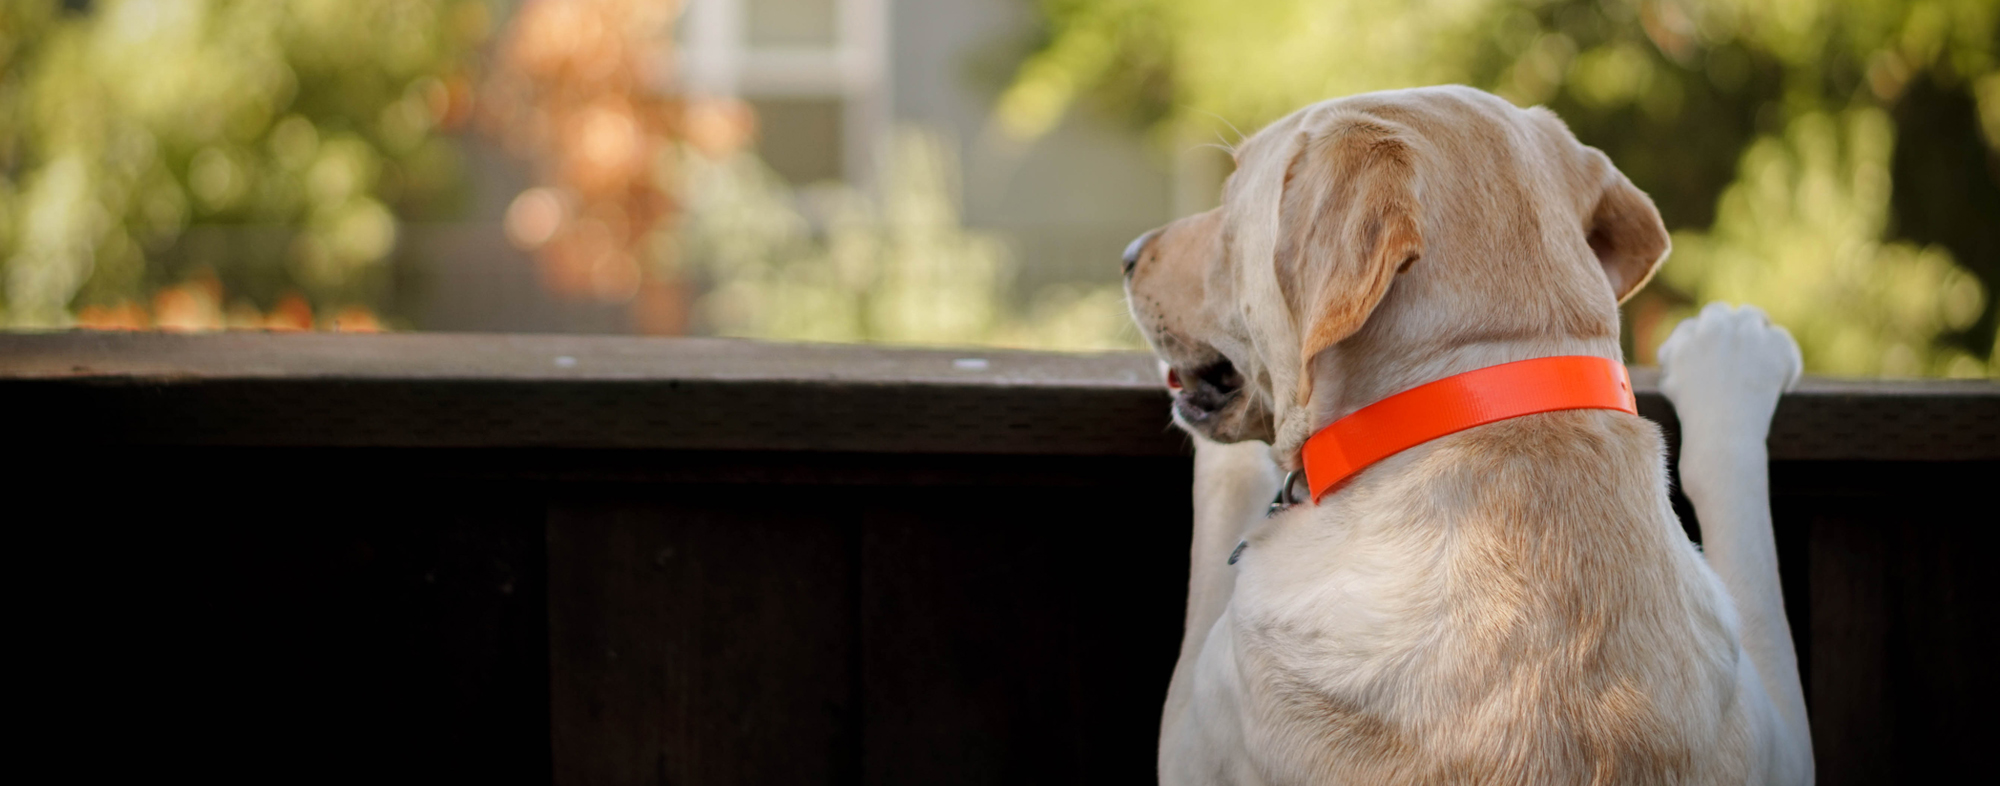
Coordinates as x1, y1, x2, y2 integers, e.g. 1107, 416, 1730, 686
0, 0, 488, 328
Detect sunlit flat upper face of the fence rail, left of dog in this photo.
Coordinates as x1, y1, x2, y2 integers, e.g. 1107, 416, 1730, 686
0, 332, 1160, 388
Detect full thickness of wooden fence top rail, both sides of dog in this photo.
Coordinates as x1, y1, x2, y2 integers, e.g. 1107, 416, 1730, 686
0, 332, 2000, 460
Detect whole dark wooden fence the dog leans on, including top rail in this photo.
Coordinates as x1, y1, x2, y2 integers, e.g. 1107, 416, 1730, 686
0, 334, 2000, 784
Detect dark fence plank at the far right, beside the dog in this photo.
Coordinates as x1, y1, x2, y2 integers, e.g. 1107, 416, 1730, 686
1800, 464, 2000, 784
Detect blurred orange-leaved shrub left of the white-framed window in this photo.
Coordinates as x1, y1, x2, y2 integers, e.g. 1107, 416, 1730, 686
482, 0, 688, 334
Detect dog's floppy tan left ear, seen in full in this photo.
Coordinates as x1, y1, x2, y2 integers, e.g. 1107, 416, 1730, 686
1272, 118, 1424, 406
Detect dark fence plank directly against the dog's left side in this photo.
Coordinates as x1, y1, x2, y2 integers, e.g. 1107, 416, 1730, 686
862, 468, 1190, 784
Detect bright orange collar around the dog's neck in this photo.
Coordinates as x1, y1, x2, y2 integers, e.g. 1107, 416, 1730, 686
1304, 356, 1638, 502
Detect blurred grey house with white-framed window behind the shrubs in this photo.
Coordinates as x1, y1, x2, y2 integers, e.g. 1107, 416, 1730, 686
412, 0, 1176, 332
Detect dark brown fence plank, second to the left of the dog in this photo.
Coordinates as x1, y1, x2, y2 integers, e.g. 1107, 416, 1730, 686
548, 486, 860, 786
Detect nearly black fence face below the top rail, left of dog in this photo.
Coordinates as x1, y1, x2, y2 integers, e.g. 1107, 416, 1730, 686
14, 448, 1190, 784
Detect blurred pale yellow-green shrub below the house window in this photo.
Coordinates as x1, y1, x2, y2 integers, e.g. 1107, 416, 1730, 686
662, 130, 1138, 350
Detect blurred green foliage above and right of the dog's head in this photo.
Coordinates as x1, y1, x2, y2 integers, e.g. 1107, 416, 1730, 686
1000, 0, 2000, 376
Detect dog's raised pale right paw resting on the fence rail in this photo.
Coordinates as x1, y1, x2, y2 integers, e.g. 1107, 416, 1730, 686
1660, 302, 1802, 434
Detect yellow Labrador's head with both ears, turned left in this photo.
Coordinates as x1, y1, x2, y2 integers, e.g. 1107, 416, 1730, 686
1124, 88, 1668, 466
